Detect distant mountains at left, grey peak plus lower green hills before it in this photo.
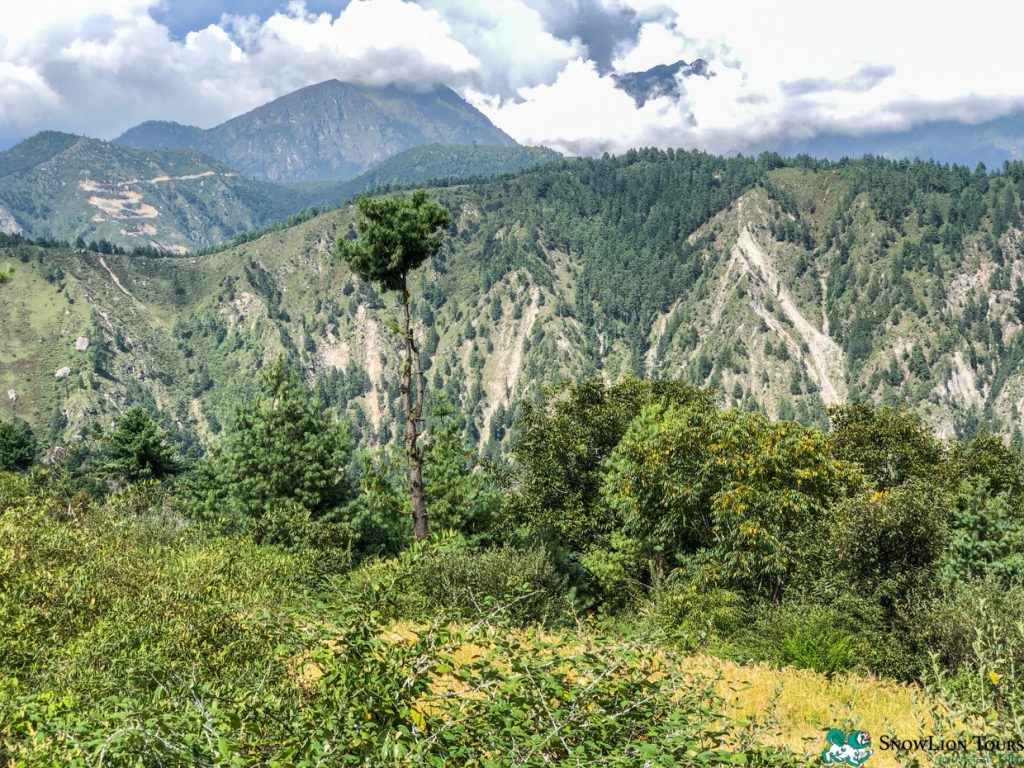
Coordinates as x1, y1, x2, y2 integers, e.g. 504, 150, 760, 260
0, 80, 561, 253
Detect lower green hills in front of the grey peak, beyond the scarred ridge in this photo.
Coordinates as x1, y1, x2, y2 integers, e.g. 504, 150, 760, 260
0, 131, 561, 253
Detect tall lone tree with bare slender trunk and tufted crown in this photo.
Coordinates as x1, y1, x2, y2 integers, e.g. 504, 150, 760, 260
338, 190, 452, 541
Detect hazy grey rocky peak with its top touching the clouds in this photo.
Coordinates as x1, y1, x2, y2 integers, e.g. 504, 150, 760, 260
116, 80, 515, 181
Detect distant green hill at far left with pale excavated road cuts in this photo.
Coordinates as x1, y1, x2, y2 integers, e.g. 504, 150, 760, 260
0, 132, 302, 253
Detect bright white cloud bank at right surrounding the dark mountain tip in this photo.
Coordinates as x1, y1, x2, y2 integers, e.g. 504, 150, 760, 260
477, 0, 1024, 154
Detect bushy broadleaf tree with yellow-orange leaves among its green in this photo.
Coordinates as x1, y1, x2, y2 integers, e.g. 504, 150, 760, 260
604, 404, 860, 595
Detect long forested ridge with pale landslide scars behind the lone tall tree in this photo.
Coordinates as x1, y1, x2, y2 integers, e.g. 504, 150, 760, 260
6, 151, 1024, 450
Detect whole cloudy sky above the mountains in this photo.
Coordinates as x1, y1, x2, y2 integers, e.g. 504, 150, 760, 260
0, 0, 1024, 155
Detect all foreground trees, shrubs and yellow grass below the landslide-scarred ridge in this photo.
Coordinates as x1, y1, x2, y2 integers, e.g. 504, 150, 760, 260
0, 370, 1024, 768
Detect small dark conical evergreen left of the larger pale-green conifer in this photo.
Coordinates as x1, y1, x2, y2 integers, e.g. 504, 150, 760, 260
98, 406, 182, 482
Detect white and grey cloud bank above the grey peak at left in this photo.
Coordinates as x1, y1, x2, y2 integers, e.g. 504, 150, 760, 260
0, 0, 480, 138
